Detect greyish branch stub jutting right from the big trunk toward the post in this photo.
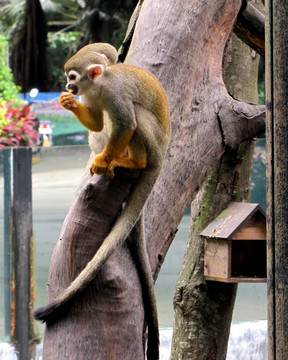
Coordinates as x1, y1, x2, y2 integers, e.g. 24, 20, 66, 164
218, 97, 266, 148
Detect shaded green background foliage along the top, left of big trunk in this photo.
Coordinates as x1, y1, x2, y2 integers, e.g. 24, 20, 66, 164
0, 0, 138, 90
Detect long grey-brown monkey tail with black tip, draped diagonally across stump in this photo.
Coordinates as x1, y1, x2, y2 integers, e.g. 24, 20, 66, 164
33, 164, 161, 322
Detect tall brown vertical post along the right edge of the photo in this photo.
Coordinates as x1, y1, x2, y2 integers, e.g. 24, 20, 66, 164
265, 1, 288, 360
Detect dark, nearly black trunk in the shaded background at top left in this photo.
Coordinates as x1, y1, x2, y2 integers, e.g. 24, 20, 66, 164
11, 0, 47, 92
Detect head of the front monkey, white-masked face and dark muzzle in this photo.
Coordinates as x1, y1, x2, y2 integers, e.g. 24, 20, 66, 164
64, 50, 107, 96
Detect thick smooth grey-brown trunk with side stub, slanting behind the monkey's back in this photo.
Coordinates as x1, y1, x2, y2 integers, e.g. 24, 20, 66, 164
125, 0, 265, 273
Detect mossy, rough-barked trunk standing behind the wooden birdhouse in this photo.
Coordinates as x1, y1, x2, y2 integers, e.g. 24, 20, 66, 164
171, 2, 259, 354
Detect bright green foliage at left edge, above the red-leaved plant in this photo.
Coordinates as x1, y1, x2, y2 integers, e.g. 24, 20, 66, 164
0, 35, 19, 101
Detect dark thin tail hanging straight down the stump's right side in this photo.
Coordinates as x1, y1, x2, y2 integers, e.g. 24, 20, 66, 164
128, 215, 159, 360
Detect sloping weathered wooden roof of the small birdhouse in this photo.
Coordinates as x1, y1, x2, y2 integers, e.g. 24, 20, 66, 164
201, 202, 266, 240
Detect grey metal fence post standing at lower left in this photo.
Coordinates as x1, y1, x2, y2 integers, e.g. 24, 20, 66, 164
4, 147, 33, 360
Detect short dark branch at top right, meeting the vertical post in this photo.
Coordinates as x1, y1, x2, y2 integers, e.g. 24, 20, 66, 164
234, 3, 265, 55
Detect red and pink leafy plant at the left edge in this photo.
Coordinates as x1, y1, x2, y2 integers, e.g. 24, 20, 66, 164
0, 100, 37, 148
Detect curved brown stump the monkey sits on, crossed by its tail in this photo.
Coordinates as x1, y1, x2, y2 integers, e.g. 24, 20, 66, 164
44, 160, 144, 360
